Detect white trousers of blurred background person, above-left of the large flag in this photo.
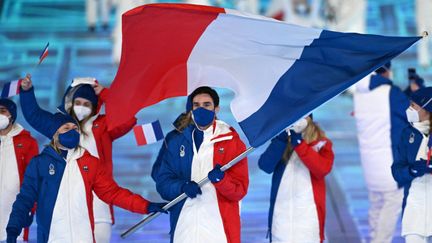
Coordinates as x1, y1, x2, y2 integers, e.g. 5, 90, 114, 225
86, 0, 110, 26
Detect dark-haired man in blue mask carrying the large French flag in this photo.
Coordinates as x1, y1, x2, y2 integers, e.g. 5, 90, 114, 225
152, 87, 249, 243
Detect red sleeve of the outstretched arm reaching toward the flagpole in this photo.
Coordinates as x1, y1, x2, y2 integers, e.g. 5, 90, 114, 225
93, 161, 149, 214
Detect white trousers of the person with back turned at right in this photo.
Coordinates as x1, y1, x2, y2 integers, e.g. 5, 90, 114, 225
369, 189, 403, 243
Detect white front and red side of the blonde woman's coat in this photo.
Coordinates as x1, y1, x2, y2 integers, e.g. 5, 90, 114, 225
272, 139, 334, 243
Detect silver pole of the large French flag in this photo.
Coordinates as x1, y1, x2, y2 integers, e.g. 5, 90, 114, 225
121, 147, 255, 239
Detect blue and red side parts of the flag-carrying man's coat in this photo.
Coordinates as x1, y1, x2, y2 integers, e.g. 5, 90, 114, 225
152, 121, 249, 242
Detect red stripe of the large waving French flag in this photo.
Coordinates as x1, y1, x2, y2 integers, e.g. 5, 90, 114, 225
106, 4, 225, 129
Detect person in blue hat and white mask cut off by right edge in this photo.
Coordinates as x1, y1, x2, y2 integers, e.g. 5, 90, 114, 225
392, 87, 432, 243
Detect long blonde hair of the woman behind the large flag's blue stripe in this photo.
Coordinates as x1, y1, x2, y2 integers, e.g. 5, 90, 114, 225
282, 117, 326, 163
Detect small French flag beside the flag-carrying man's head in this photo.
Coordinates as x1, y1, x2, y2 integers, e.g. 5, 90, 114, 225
134, 120, 164, 146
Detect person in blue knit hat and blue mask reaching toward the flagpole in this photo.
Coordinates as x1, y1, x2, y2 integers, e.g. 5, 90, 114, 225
6, 112, 162, 243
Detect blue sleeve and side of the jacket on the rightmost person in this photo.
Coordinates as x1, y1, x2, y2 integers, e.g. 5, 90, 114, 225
392, 126, 423, 212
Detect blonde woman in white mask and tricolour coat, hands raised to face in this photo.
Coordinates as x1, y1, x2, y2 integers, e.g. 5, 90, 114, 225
258, 117, 334, 243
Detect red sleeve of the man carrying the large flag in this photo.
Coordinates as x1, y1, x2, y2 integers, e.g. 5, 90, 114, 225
213, 138, 249, 201
